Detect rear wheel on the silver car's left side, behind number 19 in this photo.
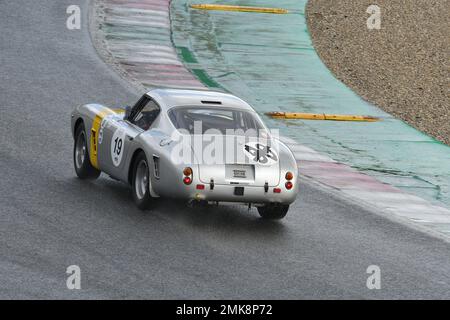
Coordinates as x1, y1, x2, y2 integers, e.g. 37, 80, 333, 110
131, 152, 153, 210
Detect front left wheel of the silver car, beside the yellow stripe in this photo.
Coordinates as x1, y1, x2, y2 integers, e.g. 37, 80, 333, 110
73, 123, 101, 180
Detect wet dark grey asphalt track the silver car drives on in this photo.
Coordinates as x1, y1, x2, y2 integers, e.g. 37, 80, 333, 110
0, 0, 450, 299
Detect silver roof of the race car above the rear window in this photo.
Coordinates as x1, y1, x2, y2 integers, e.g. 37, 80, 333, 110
147, 89, 253, 111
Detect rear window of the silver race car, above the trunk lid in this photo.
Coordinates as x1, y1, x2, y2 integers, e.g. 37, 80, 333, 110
169, 107, 265, 136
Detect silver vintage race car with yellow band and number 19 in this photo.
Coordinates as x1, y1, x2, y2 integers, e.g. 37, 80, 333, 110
71, 89, 298, 219
